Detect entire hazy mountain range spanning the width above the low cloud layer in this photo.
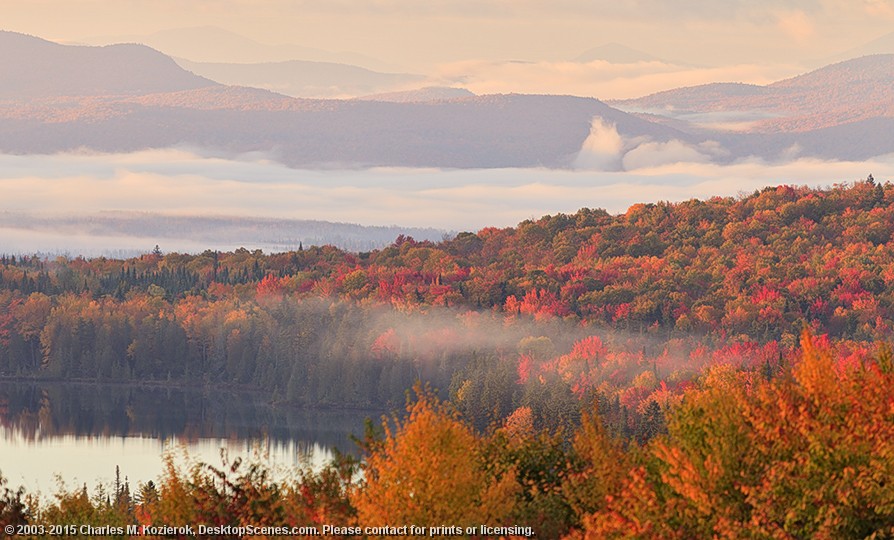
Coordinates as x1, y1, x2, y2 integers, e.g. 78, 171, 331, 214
0, 32, 894, 168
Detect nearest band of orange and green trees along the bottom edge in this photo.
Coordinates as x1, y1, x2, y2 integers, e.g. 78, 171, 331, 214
0, 334, 894, 539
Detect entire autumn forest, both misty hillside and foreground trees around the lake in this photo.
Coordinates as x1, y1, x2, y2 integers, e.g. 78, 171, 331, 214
0, 177, 894, 539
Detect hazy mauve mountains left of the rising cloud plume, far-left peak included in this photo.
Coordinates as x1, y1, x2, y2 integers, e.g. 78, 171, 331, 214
0, 30, 700, 168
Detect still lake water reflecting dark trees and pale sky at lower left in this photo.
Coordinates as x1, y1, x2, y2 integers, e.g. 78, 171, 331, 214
0, 382, 381, 496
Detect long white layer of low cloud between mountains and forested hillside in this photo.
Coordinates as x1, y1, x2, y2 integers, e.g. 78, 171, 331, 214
0, 149, 894, 239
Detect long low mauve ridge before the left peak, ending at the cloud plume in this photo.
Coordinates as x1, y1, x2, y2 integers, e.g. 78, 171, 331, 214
0, 87, 691, 168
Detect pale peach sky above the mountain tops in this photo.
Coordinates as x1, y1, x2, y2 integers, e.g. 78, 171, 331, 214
0, 0, 894, 71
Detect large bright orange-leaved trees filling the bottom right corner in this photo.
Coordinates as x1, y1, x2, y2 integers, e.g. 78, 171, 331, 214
583, 334, 894, 538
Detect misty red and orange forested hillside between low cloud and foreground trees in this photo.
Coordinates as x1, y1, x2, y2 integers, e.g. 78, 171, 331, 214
0, 180, 894, 420
